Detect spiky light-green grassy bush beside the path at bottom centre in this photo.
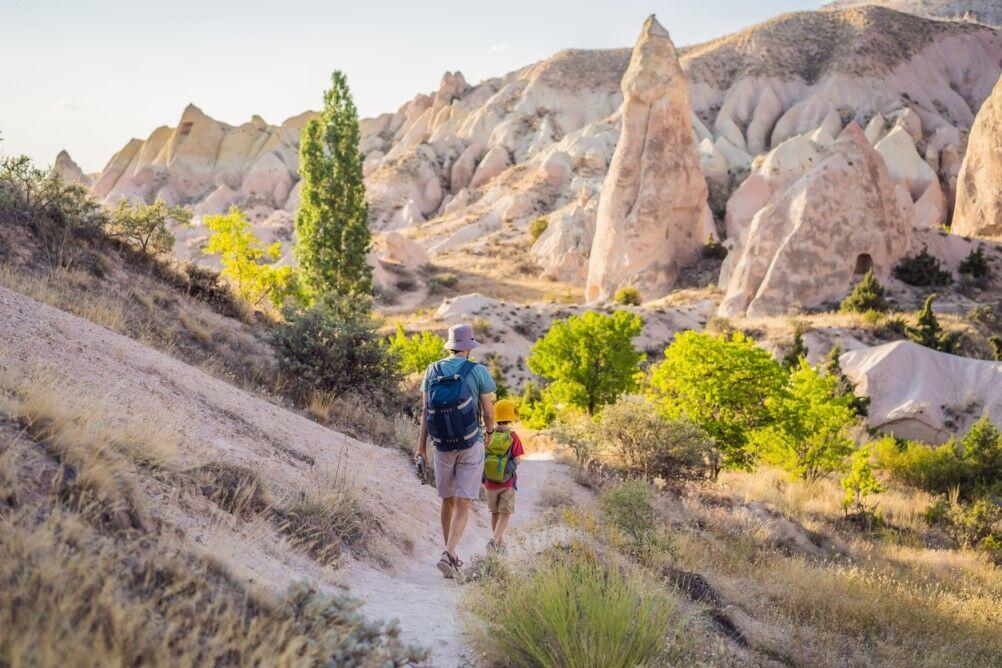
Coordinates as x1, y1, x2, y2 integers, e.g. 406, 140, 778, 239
473, 552, 677, 668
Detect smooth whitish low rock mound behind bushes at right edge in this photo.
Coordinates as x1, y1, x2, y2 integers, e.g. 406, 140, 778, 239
840, 341, 1002, 443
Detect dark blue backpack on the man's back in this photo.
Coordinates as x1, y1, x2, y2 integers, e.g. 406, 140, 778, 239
425, 360, 480, 452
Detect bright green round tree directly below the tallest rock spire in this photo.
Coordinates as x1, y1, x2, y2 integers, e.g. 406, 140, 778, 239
526, 310, 643, 415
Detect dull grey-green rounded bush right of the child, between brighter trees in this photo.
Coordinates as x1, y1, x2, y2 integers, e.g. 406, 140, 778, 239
597, 397, 713, 482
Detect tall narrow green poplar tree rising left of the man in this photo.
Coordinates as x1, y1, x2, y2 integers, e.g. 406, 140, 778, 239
296, 70, 372, 301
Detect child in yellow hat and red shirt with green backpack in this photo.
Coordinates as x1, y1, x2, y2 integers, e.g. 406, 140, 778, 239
484, 399, 525, 553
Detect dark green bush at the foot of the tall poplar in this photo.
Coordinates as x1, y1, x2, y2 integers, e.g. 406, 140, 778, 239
272, 298, 399, 399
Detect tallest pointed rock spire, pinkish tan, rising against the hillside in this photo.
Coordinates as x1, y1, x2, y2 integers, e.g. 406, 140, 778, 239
585, 16, 712, 301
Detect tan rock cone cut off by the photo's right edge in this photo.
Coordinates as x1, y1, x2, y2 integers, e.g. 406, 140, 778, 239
953, 78, 1002, 235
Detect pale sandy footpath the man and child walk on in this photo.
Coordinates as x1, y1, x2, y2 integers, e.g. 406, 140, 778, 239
345, 453, 570, 666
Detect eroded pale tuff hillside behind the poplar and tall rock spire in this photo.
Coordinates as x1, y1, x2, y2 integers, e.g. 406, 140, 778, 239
61, 7, 1002, 285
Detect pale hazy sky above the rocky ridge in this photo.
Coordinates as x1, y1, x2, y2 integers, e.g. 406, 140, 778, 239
0, 0, 820, 171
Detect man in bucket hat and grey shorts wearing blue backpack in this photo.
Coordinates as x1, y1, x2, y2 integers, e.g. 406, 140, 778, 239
415, 324, 497, 578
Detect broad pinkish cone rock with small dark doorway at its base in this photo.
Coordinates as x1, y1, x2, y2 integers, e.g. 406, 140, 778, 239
718, 123, 913, 316
